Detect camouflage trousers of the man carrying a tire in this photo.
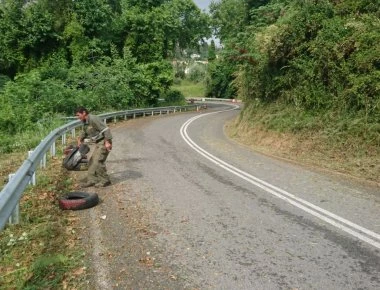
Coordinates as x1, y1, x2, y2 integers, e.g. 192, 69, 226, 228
87, 142, 110, 184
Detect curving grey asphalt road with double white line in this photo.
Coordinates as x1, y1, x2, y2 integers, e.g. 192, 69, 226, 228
80, 105, 380, 289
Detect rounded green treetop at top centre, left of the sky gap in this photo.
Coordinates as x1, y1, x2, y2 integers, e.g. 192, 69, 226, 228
119, 0, 210, 62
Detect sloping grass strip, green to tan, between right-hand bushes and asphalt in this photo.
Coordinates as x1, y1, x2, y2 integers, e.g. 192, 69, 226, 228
230, 103, 380, 182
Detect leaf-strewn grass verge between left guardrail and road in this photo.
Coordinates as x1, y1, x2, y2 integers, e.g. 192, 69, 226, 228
0, 144, 85, 290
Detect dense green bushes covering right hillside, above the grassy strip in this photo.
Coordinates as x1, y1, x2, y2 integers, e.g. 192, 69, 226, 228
209, 0, 380, 137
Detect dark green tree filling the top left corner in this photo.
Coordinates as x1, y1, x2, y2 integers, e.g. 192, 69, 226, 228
0, 0, 72, 77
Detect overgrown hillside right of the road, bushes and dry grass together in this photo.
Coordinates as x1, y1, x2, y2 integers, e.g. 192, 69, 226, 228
209, 0, 380, 181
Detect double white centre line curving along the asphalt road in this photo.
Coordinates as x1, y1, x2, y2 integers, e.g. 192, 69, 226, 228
180, 106, 380, 249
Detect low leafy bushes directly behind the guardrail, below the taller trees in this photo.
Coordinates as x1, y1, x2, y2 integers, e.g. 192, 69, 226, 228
0, 54, 172, 133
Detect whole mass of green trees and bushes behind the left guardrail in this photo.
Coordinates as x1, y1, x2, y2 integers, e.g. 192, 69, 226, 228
0, 0, 209, 153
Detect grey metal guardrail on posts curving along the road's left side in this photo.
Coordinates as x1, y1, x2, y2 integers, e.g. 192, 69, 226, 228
0, 104, 200, 230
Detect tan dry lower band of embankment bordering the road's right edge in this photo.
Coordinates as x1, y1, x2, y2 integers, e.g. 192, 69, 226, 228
225, 119, 380, 187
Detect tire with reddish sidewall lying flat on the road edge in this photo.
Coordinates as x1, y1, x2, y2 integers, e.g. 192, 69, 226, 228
59, 191, 99, 210
